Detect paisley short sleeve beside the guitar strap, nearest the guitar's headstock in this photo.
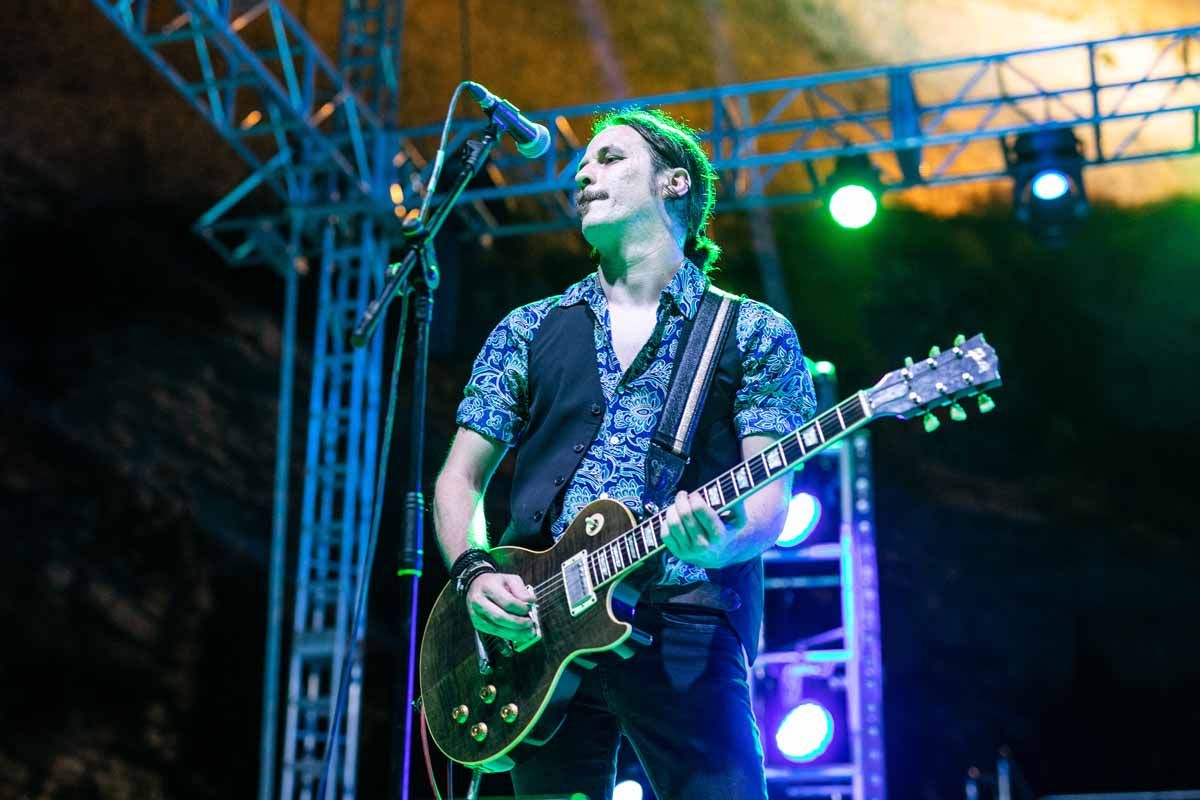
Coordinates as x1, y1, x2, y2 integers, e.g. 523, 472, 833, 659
733, 300, 816, 438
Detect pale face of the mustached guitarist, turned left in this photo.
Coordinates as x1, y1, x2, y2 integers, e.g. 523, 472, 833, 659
575, 125, 667, 247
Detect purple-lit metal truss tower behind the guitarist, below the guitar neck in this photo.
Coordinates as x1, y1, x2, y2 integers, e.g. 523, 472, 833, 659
754, 431, 887, 800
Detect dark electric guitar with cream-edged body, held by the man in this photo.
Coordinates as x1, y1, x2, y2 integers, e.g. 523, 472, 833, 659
420, 335, 1000, 772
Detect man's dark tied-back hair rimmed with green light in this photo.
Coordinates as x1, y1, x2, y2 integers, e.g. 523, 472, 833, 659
592, 108, 721, 273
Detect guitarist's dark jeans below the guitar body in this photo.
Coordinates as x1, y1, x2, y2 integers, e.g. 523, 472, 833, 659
511, 604, 767, 800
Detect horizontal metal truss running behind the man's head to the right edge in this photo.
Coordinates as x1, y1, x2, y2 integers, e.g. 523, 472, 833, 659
386, 26, 1200, 235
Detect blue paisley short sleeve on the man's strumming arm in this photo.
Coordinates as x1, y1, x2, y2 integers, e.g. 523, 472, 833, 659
455, 299, 553, 445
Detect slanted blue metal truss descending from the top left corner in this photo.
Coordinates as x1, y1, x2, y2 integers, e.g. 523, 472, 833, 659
92, 0, 392, 225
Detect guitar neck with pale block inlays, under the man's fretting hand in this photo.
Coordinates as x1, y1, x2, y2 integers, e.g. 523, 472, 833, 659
588, 392, 871, 587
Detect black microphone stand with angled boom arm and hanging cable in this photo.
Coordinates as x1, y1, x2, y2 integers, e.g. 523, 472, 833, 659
317, 118, 508, 800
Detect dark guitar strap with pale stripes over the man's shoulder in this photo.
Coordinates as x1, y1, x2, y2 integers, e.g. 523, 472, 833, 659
646, 284, 742, 513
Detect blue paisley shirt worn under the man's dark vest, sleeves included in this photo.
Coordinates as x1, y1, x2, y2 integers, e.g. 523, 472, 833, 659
456, 261, 816, 584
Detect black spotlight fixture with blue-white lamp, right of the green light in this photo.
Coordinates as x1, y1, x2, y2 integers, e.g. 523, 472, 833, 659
1004, 127, 1087, 245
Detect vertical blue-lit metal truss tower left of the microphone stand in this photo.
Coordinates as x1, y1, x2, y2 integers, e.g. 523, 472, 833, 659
278, 221, 388, 800
